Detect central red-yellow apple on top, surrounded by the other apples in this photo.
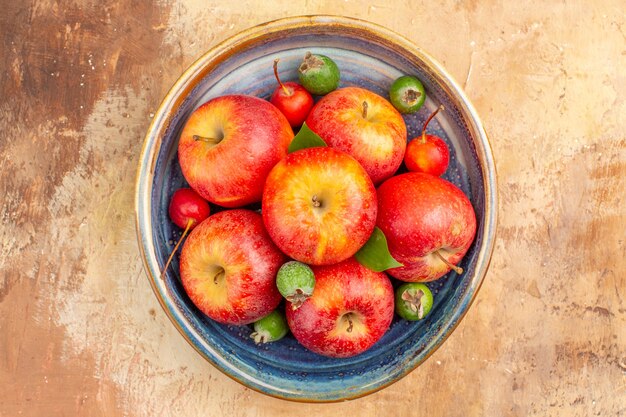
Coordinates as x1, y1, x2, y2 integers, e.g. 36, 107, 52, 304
263, 147, 377, 265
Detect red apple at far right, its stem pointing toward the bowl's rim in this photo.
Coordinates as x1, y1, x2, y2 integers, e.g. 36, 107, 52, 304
376, 172, 476, 282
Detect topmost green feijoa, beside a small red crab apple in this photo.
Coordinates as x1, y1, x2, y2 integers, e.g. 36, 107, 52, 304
298, 52, 340, 96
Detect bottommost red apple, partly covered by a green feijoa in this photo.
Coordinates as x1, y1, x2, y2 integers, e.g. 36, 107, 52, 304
285, 258, 394, 358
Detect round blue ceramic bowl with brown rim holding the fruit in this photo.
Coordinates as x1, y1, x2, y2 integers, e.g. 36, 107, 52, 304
136, 16, 496, 402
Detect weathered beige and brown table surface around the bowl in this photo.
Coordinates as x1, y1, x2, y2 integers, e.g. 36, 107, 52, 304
0, 0, 626, 417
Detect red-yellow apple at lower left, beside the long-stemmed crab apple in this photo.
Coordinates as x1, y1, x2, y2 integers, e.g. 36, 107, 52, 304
180, 209, 285, 325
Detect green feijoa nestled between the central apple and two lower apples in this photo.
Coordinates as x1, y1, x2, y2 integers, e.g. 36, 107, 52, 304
276, 261, 315, 310
